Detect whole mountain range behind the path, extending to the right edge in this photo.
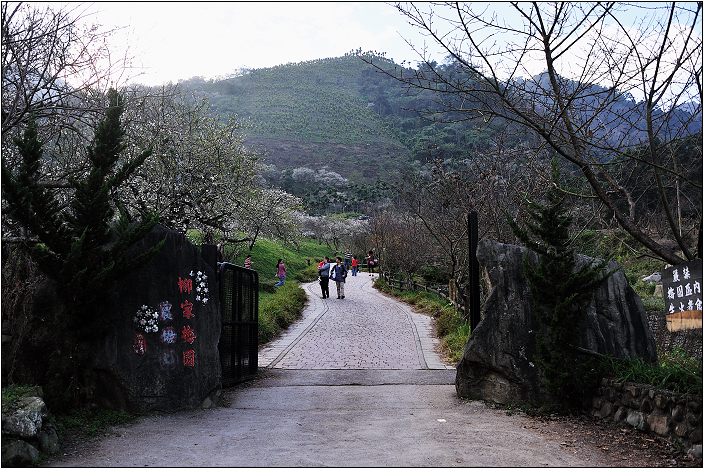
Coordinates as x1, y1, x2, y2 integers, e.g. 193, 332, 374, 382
176, 50, 702, 212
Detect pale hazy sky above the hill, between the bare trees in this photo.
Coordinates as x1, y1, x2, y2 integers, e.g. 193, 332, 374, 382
77, 2, 442, 85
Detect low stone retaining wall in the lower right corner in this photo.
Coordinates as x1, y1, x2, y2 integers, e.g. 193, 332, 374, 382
592, 378, 702, 448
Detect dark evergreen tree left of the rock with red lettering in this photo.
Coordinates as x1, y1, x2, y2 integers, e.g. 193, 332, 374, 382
2, 89, 163, 408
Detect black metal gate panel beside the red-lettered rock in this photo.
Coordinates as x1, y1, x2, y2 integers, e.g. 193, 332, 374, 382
219, 263, 259, 386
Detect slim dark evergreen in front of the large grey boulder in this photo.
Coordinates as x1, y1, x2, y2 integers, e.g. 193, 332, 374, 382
508, 158, 611, 406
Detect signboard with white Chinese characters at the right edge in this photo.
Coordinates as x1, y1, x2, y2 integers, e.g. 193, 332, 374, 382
662, 259, 704, 332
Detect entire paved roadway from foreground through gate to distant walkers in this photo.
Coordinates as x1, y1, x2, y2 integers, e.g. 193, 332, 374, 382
48, 272, 692, 467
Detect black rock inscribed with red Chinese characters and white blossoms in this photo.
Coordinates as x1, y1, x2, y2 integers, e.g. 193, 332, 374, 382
95, 227, 222, 412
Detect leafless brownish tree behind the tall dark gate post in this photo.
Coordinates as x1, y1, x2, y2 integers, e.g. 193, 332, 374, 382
396, 148, 548, 283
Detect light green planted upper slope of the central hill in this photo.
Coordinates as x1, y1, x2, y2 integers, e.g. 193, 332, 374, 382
210, 55, 398, 144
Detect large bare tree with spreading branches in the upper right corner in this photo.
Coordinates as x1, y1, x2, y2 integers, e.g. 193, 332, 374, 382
377, 2, 702, 264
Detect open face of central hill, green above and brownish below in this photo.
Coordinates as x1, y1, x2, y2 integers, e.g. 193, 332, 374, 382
183, 55, 416, 186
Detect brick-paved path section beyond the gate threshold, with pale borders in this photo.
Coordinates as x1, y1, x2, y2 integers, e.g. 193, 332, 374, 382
259, 272, 454, 370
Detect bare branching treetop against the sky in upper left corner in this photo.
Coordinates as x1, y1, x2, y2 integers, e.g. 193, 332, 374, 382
0, 2, 129, 145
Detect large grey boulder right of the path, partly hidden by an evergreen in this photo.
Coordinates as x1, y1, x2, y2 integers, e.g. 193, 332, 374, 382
455, 239, 657, 405
